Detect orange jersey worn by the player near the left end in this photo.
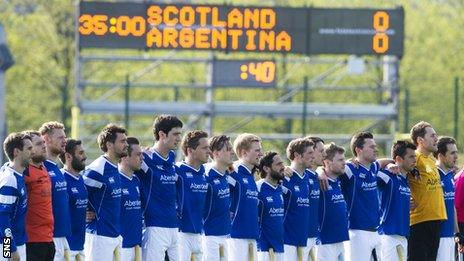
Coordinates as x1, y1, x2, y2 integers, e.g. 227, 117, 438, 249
24, 165, 53, 242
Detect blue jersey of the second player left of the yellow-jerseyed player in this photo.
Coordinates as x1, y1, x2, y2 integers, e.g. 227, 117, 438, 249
340, 161, 380, 230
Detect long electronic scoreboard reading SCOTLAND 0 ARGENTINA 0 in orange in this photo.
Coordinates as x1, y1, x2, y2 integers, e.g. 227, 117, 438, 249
77, 2, 404, 56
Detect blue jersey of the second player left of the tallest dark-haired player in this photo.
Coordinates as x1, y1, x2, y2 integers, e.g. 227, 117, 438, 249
84, 156, 121, 237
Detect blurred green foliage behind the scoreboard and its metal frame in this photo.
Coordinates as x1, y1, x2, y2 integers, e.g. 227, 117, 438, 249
0, 0, 464, 158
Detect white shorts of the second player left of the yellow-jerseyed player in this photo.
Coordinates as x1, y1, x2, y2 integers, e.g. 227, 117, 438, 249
345, 229, 380, 261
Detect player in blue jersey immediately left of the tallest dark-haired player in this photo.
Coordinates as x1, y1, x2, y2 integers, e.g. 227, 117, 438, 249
118, 137, 143, 261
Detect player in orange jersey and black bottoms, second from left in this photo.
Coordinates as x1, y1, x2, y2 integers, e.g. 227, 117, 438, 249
24, 130, 55, 260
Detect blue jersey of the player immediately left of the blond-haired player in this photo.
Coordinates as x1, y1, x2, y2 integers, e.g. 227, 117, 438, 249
203, 168, 231, 236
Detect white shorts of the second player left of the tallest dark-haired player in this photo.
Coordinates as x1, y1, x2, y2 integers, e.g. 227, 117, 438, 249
84, 233, 122, 261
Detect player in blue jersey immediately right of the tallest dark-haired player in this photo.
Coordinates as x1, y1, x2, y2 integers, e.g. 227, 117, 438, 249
176, 130, 210, 261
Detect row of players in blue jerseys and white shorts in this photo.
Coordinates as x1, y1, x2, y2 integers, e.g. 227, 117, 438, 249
0, 115, 457, 260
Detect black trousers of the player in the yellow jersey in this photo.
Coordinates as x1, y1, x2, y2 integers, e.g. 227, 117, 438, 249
408, 220, 442, 261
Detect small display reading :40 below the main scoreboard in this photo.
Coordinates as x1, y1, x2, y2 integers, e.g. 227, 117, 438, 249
213, 60, 277, 87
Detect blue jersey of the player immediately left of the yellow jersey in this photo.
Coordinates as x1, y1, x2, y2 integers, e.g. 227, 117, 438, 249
377, 170, 411, 237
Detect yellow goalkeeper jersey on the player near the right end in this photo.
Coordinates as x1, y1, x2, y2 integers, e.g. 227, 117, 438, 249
408, 151, 447, 225
